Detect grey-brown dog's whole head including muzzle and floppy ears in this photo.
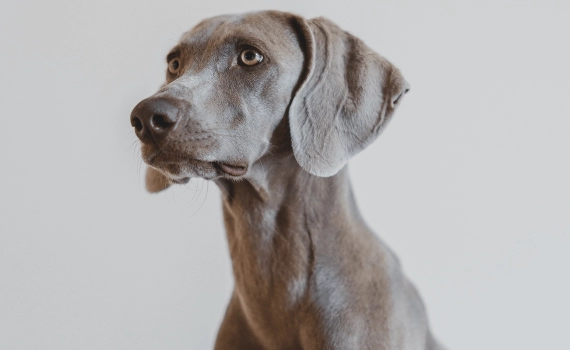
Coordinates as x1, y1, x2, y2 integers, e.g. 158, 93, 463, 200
131, 11, 409, 192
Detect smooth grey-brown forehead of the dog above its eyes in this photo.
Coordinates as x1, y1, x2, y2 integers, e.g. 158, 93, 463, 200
179, 11, 296, 52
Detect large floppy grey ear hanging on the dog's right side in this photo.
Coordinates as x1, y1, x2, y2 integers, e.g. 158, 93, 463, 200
289, 17, 409, 176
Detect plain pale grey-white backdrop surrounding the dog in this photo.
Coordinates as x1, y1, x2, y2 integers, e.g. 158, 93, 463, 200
0, 0, 570, 350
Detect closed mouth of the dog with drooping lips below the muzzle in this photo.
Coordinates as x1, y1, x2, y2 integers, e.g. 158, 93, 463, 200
141, 147, 248, 180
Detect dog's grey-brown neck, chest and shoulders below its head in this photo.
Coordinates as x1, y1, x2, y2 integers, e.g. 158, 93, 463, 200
216, 153, 437, 349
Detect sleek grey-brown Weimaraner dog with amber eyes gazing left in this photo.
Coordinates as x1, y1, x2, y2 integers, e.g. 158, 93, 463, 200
131, 11, 441, 350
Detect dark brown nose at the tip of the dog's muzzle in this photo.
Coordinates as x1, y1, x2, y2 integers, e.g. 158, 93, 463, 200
131, 97, 179, 143
